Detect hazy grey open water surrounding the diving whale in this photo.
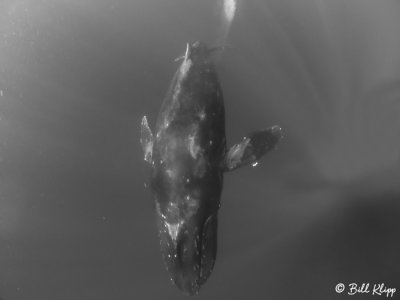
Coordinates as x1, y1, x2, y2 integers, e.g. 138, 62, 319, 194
0, 0, 400, 300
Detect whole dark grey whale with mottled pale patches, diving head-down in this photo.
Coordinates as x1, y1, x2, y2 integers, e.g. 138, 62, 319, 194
141, 42, 281, 295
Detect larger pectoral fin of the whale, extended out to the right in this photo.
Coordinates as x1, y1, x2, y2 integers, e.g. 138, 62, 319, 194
223, 126, 282, 172
